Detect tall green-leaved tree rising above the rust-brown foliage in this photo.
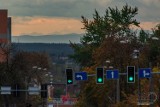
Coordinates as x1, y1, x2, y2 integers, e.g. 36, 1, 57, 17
71, 4, 139, 67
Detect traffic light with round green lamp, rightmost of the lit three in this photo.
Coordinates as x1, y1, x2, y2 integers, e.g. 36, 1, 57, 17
127, 66, 135, 83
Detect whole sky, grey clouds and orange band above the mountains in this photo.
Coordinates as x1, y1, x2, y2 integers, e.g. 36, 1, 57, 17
0, 0, 160, 36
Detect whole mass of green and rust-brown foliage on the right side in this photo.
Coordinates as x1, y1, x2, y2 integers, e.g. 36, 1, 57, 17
71, 0, 160, 107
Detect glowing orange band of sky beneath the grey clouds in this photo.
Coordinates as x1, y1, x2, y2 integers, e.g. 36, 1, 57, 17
12, 17, 158, 36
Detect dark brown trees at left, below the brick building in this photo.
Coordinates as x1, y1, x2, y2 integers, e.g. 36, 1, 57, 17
0, 44, 50, 107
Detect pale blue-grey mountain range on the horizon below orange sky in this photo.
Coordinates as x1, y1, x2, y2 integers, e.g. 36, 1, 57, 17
12, 34, 83, 43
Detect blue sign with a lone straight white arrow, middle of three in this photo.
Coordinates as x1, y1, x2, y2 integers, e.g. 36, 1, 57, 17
106, 70, 119, 79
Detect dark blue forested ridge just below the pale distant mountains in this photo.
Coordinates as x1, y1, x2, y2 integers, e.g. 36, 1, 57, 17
12, 43, 73, 56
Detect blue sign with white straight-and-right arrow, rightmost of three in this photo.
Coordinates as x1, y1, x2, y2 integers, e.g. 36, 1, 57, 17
138, 68, 151, 78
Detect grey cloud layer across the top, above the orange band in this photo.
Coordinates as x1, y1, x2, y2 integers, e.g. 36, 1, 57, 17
0, 0, 160, 21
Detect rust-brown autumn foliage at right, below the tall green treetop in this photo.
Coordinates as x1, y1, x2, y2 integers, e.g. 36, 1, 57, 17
77, 20, 160, 107
